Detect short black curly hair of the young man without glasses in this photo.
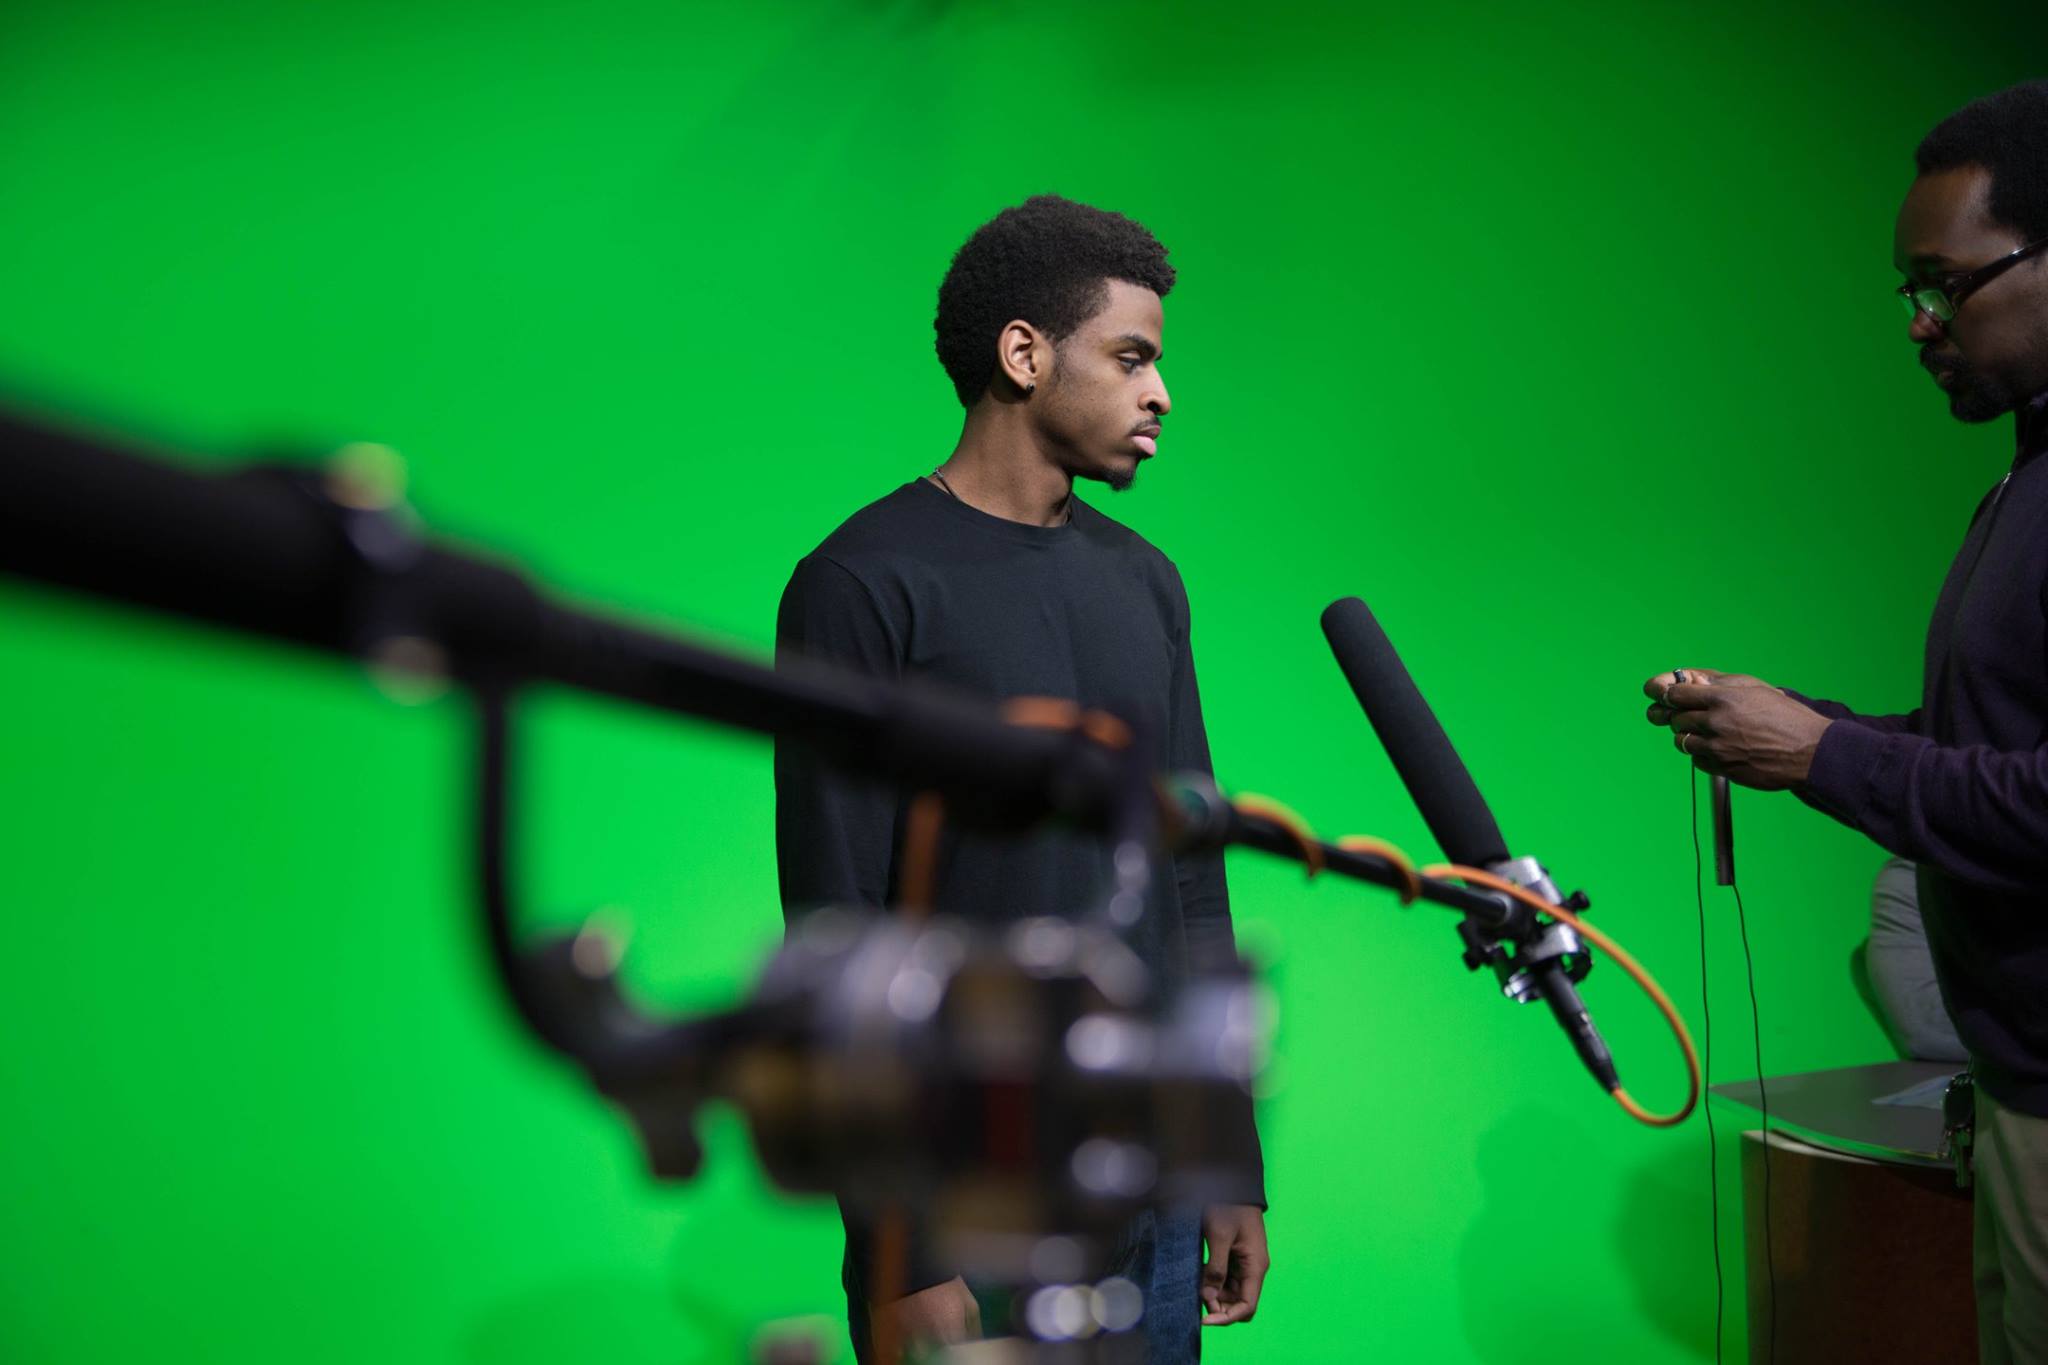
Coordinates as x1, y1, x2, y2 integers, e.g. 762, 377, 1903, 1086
932, 194, 1174, 407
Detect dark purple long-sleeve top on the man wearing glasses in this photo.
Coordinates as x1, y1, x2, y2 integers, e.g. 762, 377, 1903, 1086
1794, 395, 2048, 1117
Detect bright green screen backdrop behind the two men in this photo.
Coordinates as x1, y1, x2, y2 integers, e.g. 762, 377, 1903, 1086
0, 0, 2048, 1363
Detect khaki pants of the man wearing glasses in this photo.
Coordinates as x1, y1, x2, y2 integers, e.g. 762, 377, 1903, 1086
1972, 1087, 2048, 1365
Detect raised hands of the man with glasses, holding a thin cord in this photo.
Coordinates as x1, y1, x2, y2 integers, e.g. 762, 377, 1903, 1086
1642, 669, 1831, 792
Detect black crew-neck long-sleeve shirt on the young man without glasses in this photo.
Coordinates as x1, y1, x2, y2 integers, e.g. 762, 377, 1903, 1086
774, 479, 1264, 1289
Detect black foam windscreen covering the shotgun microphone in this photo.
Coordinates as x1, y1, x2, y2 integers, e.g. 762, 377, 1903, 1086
1323, 598, 1507, 868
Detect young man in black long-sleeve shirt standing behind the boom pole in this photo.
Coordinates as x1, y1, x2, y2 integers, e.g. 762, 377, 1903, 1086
776, 194, 1268, 1365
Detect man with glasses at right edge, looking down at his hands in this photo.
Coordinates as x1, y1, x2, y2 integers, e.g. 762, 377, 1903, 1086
1645, 82, 2048, 1365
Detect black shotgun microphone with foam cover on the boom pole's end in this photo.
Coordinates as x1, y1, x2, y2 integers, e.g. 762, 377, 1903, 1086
1323, 598, 1620, 1091
